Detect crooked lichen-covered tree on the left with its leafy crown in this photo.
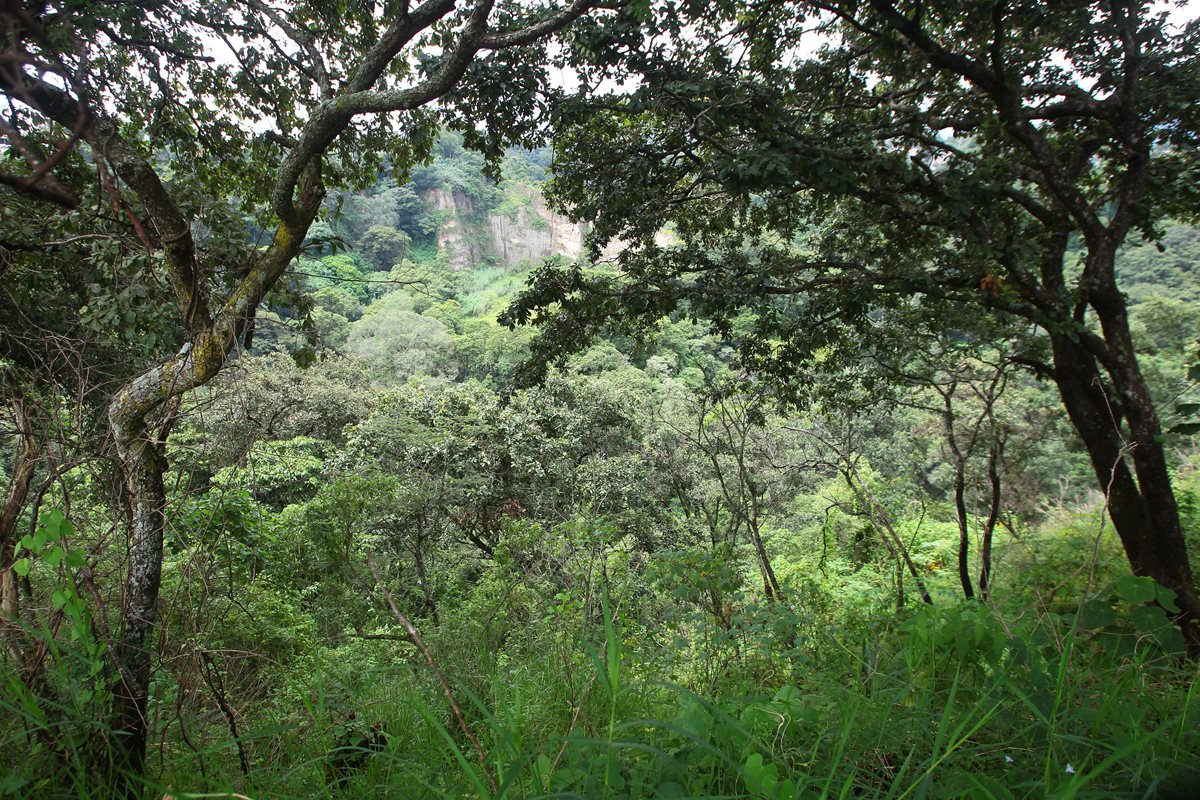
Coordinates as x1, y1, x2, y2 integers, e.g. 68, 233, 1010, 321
0, 0, 609, 777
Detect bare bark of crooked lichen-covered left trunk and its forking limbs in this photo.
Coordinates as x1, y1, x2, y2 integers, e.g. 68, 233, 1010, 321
0, 0, 604, 795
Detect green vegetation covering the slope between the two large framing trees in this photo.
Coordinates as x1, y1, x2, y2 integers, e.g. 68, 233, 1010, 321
6, 137, 1200, 798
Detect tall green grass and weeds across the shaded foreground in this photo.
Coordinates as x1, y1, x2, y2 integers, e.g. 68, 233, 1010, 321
9, 578, 1200, 800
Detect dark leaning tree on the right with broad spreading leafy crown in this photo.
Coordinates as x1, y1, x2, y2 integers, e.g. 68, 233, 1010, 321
506, 0, 1200, 655
